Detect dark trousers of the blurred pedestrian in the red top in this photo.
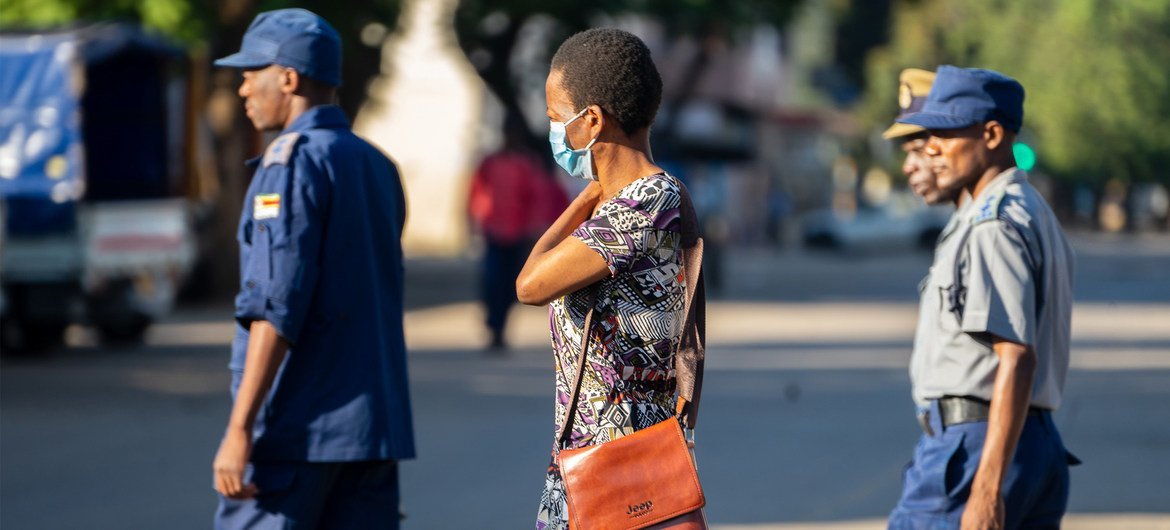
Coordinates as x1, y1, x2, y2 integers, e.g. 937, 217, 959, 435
480, 239, 532, 340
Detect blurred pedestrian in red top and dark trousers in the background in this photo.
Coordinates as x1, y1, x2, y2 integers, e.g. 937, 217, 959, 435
468, 122, 569, 350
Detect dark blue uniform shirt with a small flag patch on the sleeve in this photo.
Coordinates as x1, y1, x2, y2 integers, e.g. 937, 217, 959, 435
230, 105, 414, 461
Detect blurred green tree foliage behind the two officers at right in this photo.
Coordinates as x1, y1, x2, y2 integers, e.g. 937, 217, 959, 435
862, 0, 1170, 183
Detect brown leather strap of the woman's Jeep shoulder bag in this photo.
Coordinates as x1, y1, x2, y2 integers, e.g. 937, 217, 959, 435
557, 179, 707, 448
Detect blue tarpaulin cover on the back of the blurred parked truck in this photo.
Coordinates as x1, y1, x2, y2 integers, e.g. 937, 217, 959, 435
0, 23, 183, 234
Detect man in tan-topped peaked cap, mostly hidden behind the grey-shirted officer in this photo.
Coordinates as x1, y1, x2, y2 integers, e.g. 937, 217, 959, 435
881, 68, 966, 206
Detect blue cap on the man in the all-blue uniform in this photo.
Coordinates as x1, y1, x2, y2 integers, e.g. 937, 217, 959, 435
215, 9, 342, 87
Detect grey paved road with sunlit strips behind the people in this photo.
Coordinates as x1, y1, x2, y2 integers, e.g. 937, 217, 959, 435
0, 238, 1170, 530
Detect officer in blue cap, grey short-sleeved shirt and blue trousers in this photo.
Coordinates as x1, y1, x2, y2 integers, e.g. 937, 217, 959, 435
889, 66, 1074, 529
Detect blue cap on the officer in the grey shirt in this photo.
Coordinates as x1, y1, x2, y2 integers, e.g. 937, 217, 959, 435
897, 66, 1024, 131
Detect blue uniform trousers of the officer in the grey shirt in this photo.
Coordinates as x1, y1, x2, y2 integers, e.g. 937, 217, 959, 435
889, 401, 1075, 530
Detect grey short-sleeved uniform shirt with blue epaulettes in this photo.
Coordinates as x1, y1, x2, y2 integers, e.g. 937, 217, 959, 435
910, 168, 1074, 409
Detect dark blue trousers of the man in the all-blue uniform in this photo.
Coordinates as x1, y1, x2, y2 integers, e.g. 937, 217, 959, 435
215, 460, 400, 530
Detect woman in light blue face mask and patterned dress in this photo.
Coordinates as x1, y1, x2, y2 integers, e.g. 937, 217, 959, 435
516, 29, 686, 530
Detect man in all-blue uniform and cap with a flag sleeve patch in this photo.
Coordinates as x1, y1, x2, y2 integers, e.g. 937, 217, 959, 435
213, 9, 414, 529
